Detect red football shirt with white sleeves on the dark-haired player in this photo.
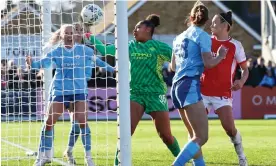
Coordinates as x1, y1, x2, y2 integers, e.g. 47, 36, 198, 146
201, 37, 246, 98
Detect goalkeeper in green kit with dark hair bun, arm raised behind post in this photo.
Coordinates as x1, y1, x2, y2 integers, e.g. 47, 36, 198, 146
86, 14, 180, 165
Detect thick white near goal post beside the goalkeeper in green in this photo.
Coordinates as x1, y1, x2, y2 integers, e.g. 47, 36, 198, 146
115, 0, 131, 166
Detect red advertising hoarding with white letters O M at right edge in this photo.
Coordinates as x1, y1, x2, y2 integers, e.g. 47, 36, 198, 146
241, 87, 276, 119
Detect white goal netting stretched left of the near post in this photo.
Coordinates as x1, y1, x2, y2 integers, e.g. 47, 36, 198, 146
1, 0, 129, 165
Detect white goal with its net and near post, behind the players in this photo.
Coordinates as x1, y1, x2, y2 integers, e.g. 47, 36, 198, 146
1, 0, 131, 166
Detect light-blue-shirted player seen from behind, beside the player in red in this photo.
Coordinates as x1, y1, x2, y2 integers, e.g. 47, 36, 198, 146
171, 1, 226, 166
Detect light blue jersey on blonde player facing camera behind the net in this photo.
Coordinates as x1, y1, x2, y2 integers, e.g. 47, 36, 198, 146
32, 44, 114, 96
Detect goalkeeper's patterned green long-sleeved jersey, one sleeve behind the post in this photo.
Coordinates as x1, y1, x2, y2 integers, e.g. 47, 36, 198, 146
85, 35, 172, 94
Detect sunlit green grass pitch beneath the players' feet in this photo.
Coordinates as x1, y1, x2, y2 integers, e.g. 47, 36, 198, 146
1, 120, 276, 166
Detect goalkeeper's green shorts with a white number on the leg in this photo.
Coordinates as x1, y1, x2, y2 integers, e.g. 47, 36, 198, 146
130, 94, 169, 114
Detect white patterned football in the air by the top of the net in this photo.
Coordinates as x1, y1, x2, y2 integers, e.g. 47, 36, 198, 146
81, 4, 103, 25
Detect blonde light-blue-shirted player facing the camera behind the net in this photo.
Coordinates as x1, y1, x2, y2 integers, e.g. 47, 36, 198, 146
27, 25, 114, 166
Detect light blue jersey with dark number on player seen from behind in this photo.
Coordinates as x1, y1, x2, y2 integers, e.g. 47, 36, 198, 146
173, 25, 212, 83
